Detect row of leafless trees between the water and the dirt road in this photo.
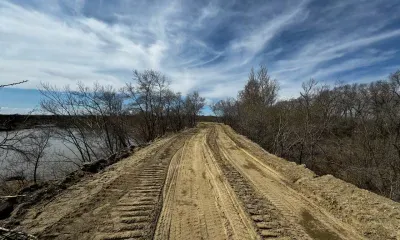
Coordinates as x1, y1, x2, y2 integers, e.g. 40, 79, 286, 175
41, 70, 204, 162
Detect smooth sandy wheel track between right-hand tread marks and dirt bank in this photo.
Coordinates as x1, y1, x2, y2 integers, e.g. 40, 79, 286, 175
213, 126, 363, 240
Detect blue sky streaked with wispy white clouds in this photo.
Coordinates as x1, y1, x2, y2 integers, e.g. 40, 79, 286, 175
0, 0, 400, 113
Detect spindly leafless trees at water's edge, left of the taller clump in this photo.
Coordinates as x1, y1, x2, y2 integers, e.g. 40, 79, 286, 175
41, 84, 130, 162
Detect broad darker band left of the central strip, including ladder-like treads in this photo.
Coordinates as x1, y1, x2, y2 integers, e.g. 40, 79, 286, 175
40, 133, 191, 240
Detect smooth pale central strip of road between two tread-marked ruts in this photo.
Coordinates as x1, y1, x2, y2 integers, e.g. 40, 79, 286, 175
155, 126, 257, 239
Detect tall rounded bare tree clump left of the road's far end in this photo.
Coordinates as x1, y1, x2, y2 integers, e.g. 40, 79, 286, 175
124, 70, 205, 141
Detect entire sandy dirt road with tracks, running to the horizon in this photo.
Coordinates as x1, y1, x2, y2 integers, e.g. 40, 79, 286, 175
12, 123, 400, 239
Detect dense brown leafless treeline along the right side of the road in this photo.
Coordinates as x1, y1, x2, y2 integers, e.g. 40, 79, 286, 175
212, 67, 400, 201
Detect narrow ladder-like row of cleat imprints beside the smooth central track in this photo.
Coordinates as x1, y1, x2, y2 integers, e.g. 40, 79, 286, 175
95, 135, 190, 240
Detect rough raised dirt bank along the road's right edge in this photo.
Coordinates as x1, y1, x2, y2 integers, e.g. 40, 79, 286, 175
219, 125, 400, 239
